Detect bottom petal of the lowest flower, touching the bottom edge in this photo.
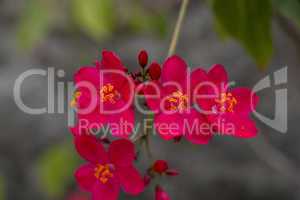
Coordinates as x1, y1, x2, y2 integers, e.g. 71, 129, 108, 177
92, 179, 120, 200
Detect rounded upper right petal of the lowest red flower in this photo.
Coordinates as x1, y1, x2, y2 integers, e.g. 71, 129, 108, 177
109, 139, 135, 167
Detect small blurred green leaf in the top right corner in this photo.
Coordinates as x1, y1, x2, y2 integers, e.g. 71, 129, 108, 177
273, 0, 300, 27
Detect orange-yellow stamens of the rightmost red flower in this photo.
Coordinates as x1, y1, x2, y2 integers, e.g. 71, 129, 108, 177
215, 92, 238, 112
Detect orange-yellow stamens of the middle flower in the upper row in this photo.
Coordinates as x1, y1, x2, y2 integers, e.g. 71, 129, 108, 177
167, 90, 188, 111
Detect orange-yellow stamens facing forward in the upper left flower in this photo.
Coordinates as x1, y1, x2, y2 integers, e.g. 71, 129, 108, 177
100, 83, 120, 104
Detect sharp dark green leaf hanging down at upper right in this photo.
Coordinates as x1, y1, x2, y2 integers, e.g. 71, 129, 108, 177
211, 0, 273, 68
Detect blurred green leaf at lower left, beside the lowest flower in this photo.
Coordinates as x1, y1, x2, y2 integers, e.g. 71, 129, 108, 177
37, 143, 79, 198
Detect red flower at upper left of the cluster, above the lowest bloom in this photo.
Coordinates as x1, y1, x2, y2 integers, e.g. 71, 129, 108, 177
71, 51, 134, 137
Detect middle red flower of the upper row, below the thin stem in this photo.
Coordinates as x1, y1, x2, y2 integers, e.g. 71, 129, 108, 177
144, 56, 212, 144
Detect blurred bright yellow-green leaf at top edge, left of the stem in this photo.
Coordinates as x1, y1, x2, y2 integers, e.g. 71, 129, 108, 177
72, 0, 116, 41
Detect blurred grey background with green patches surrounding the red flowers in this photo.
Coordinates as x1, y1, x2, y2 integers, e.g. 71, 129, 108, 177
0, 0, 300, 200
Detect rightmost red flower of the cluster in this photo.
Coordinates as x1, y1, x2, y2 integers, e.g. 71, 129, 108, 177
192, 65, 259, 138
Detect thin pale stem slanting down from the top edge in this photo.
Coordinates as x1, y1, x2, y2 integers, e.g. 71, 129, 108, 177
168, 0, 189, 56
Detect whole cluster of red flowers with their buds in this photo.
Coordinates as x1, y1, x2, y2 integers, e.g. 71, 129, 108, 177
70, 50, 258, 200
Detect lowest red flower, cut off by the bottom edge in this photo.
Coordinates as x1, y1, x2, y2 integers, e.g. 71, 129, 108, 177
75, 136, 144, 200
